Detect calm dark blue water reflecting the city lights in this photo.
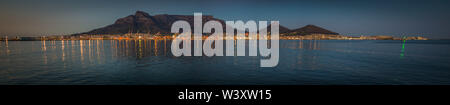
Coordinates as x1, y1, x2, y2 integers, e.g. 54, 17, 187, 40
0, 40, 450, 85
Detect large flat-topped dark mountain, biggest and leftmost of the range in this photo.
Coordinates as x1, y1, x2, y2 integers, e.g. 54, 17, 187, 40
81, 11, 225, 34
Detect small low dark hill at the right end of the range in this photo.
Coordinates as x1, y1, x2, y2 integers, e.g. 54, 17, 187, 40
286, 25, 339, 35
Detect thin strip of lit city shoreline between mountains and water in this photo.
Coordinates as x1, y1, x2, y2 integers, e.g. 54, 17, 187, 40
0, 34, 428, 41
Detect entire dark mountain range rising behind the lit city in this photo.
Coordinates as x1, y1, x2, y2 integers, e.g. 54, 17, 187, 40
74, 11, 338, 35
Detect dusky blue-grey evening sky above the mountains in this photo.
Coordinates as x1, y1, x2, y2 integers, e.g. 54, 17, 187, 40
0, 0, 450, 38
